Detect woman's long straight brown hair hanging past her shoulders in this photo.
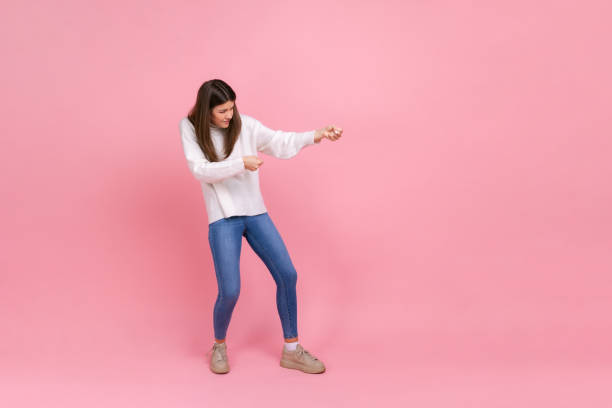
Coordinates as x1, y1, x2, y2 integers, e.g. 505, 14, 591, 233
187, 79, 242, 162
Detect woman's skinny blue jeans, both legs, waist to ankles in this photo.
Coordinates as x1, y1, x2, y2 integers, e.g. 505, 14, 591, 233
208, 212, 297, 340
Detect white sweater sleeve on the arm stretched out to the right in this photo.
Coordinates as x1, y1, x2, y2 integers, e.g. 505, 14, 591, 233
252, 118, 315, 159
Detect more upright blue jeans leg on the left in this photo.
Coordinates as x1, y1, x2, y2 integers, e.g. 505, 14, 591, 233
208, 218, 244, 343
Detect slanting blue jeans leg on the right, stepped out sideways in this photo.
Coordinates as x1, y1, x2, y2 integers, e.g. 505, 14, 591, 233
245, 212, 297, 341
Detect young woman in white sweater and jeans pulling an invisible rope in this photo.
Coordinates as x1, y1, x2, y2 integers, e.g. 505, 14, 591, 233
180, 79, 342, 374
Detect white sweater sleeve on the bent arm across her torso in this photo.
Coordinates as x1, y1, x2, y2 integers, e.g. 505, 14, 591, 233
179, 119, 246, 183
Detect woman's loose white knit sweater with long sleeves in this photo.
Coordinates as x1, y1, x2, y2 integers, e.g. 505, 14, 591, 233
179, 113, 315, 224
